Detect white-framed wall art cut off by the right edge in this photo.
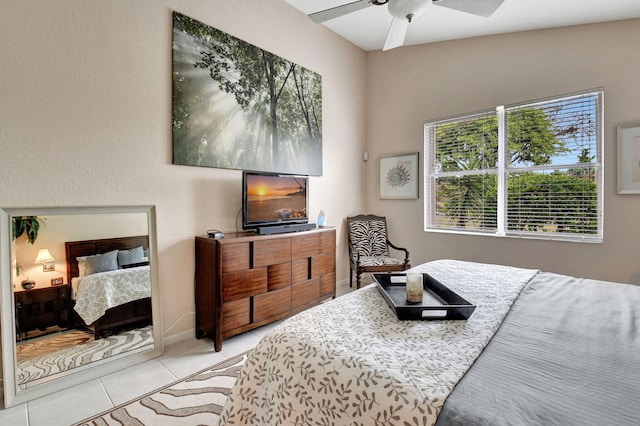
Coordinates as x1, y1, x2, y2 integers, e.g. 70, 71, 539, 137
617, 122, 640, 194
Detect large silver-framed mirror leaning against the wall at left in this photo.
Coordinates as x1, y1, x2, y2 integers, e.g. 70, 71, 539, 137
0, 206, 163, 407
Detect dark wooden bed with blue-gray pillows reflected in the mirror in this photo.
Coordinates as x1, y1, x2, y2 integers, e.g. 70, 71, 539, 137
65, 235, 151, 339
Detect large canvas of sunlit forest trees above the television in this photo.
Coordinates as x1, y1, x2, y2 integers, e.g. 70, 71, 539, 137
172, 12, 322, 176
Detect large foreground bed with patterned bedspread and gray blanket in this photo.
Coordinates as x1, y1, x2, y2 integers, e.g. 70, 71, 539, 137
221, 260, 640, 426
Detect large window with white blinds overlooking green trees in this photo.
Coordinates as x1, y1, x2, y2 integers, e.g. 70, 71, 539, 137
425, 90, 604, 242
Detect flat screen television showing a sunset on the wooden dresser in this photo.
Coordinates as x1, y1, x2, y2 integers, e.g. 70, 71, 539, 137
242, 170, 309, 230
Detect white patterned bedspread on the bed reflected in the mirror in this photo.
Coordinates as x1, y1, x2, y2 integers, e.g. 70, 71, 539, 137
73, 266, 151, 325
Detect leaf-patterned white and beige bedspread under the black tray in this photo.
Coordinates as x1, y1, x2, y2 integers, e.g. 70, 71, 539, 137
221, 260, 537, 425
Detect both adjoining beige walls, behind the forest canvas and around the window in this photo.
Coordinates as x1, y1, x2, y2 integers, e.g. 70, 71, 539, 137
5, 0, 640, 344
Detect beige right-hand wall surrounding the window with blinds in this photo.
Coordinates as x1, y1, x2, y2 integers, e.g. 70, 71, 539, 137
366, 19, 640, 283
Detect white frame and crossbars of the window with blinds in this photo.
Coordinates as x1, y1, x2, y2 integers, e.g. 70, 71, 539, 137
423, 87, 604, 243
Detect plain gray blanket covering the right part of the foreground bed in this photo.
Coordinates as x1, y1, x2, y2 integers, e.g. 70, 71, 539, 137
437, 273, 640, 426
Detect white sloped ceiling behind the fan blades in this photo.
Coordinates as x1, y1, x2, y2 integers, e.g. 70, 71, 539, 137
284, 0, 640, 51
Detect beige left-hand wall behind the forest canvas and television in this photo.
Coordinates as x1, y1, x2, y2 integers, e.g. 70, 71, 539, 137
0, 0, 366, 337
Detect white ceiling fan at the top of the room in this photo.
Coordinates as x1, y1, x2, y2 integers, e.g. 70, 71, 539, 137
309, 0, 504, 50
